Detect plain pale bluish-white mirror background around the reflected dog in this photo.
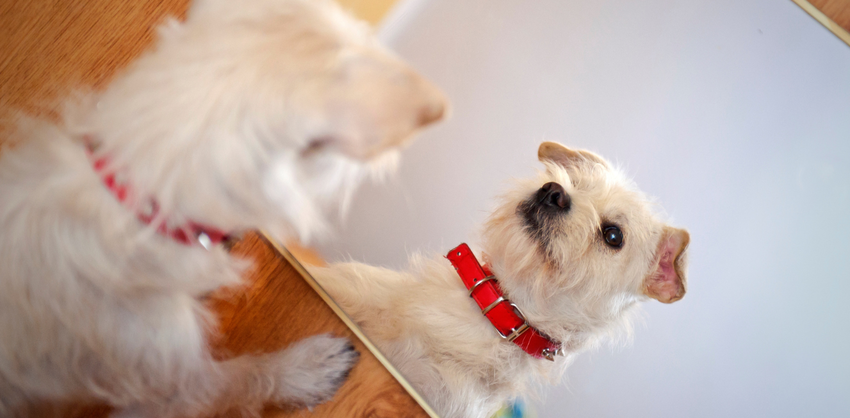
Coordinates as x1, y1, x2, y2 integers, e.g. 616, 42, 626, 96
314, 0, 850, 418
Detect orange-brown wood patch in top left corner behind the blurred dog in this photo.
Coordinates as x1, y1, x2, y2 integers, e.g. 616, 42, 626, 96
0, 0, 189, 121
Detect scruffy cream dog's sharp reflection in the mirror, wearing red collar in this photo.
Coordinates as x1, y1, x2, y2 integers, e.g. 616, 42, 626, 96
310, 142, 689, 418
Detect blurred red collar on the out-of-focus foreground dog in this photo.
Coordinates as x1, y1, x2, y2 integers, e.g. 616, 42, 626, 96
86, 141, 231, 250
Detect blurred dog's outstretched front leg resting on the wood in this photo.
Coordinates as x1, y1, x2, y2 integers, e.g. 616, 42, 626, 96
114, 334, 360, 418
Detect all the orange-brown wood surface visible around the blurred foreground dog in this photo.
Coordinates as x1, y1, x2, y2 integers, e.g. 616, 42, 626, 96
0, 0, 427, 418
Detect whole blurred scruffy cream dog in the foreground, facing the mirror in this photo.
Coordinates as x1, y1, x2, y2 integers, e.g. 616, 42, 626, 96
0, 0, 445, 417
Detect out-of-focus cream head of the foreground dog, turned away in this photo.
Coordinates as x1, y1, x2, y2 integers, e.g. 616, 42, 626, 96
79, 0, 447, 238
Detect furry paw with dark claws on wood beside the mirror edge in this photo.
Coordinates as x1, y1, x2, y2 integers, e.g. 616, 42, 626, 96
273, 334, 360, 407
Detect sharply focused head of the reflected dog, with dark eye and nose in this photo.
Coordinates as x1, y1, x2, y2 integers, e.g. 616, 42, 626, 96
484, 142, 689, 349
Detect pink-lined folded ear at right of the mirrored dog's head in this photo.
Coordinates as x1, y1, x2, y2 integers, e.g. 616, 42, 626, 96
642, 226, 691, 303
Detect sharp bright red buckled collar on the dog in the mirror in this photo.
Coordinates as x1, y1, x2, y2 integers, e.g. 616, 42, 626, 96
446, 244, 563, 361
